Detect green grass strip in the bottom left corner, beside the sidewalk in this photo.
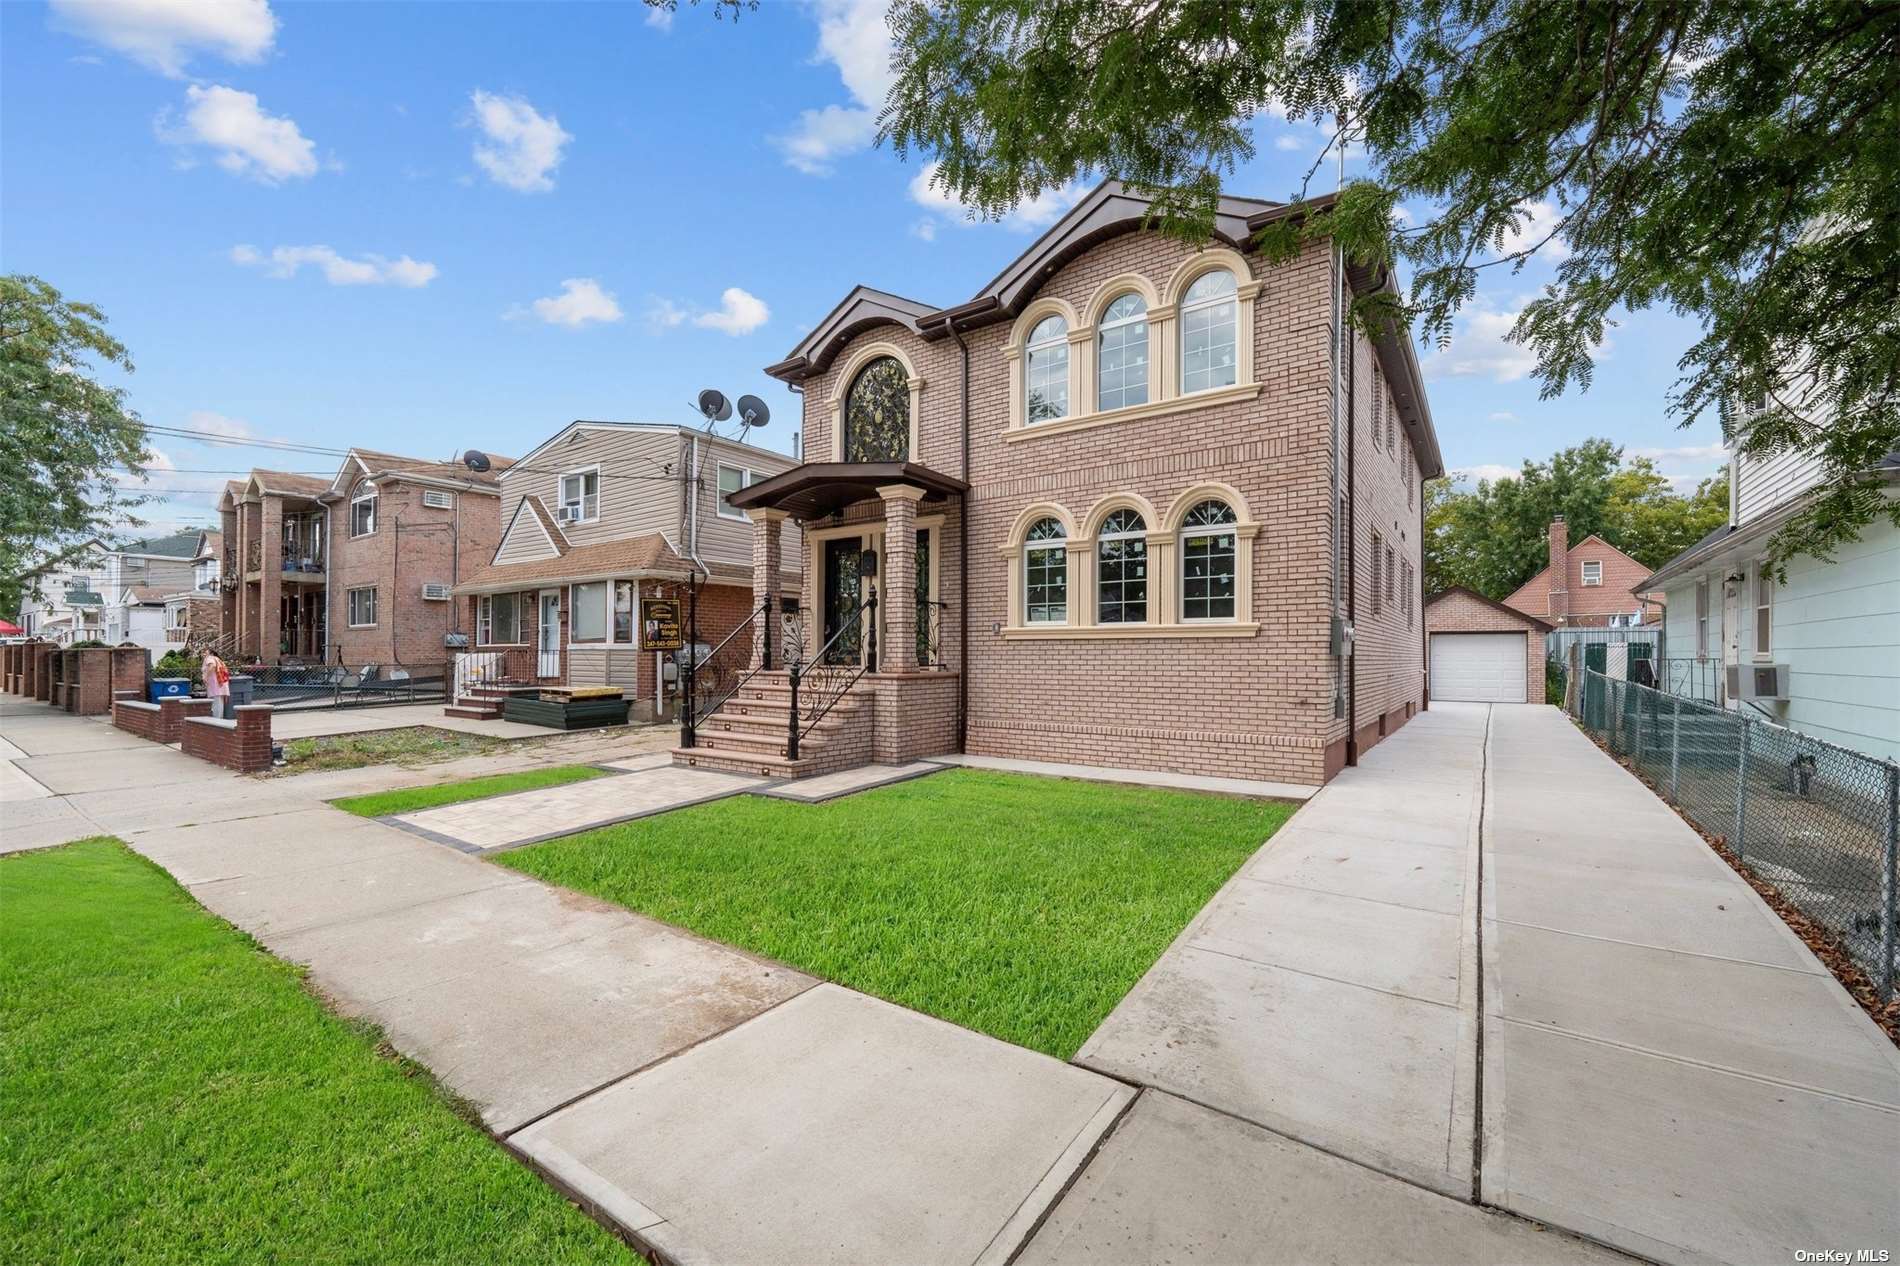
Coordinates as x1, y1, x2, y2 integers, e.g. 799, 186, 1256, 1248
0, 838, 637, 1264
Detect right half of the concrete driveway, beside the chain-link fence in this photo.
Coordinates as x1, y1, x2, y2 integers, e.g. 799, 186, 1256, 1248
1482, 707, 1900, 1262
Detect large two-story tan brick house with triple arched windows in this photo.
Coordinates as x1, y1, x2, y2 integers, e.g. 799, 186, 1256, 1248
699, 182, 1442, 785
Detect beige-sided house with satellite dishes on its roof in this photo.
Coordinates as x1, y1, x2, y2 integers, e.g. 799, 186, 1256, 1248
456, 422, 798, 719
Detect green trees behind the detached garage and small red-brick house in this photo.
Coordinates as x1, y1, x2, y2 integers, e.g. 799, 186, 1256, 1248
1423, 439, 1729, 610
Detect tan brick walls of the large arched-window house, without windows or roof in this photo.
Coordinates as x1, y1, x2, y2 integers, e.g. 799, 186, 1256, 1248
771, 198, 1425, 783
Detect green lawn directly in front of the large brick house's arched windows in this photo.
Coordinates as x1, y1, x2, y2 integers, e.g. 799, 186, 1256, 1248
496, 770, 1294, 1059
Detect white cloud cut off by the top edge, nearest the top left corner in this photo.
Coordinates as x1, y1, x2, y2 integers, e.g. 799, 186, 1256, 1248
51, 0, 277, 78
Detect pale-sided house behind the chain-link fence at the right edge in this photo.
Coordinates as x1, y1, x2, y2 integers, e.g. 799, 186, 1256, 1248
1644, 407, 1900, 760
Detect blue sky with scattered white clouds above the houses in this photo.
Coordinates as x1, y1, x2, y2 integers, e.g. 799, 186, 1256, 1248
0, 0, 1720, 527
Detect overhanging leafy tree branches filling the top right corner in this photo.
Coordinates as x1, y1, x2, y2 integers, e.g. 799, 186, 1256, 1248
884, 0, 1900, 559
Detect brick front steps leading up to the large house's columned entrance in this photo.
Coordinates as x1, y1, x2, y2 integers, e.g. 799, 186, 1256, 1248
673, 671, 876, 779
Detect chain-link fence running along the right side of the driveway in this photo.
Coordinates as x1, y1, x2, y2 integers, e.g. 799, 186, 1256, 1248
1568, 669, 1900, 1000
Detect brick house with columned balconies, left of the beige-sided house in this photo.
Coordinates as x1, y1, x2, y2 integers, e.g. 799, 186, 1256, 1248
219, 449, 507, 677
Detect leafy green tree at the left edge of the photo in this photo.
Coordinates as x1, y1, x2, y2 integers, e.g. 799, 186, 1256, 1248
0, 276, 152, 612
